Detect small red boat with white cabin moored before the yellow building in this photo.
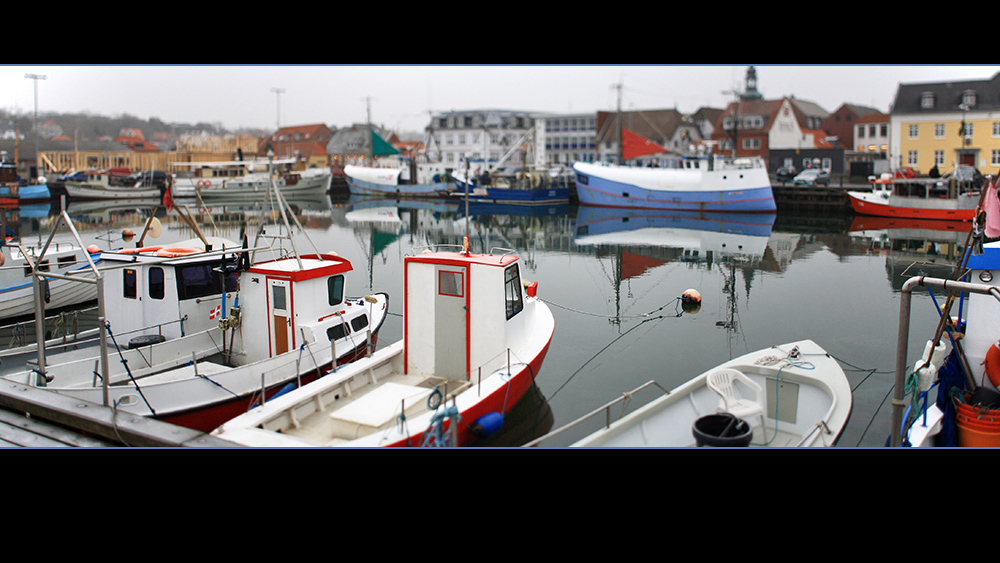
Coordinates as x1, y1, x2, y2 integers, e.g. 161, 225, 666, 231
847, 174, 980, 221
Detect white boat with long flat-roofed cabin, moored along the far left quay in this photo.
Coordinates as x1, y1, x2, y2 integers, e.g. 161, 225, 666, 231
170, 159, 333, 199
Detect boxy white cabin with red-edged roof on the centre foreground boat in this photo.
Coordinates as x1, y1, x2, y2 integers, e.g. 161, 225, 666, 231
403, 252, 535, 381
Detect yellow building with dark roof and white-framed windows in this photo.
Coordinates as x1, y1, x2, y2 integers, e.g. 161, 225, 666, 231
889, 73, 1000, 174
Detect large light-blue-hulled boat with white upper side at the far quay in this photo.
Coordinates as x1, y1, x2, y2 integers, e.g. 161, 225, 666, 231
573, 157, 777, 213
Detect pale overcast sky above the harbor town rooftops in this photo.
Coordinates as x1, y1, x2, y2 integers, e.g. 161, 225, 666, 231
0, 65, 1000, 131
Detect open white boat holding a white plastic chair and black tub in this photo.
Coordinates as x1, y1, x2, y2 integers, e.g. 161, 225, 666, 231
527, 340, 852, 448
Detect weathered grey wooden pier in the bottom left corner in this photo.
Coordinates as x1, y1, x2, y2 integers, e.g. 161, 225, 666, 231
0, 381, 240, 448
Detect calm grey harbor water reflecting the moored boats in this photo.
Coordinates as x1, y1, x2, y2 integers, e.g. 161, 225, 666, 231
6, 196, 968, 447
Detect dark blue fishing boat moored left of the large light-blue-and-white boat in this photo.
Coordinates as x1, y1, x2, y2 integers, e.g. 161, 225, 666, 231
447, 170, 569, 205
